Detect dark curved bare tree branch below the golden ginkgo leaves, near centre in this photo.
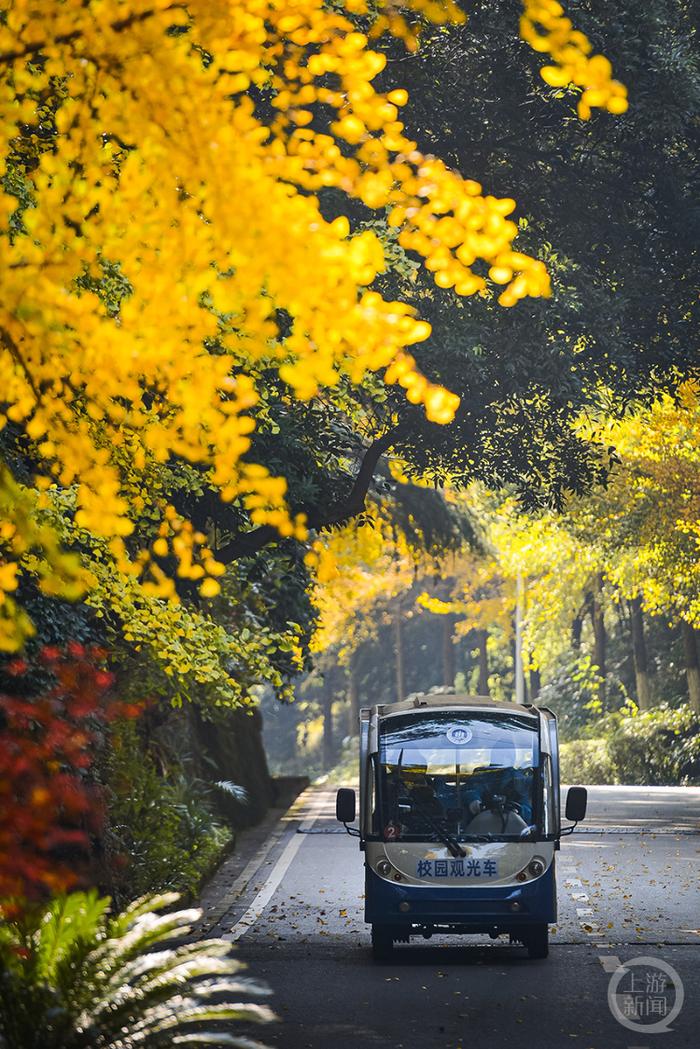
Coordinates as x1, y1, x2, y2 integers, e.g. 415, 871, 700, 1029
216, 424, 407, 564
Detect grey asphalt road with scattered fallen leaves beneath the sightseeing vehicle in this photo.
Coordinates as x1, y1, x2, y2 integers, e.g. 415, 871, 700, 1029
205, 787, 700, 1049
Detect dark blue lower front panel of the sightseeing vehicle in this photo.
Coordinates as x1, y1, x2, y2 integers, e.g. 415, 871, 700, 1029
364, 864, 556, 933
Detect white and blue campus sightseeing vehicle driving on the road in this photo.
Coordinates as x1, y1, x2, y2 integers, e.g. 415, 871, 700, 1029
336, 690, 587, 959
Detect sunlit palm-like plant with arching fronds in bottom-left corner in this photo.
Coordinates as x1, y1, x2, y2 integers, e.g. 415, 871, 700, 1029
0, 892, 274, 1049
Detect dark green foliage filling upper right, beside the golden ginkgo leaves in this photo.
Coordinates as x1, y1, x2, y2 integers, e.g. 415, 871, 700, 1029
383, 0, 700, 480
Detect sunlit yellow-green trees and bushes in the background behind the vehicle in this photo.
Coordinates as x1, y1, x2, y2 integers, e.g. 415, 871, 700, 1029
263, 383, 700, 785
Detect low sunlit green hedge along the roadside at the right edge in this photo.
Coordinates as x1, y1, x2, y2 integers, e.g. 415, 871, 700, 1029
560, 705, 700, 787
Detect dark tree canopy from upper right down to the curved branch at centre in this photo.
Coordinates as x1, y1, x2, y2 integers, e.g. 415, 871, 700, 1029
229, 0, 700, 555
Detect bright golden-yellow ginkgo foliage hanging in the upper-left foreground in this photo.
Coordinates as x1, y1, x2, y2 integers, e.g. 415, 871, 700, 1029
0, 0, 625, 650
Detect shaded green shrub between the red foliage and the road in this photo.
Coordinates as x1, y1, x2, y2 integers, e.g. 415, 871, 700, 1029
105, 723, 233, 899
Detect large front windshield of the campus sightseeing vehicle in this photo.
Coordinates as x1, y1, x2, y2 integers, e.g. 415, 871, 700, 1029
378, 710, 539, 842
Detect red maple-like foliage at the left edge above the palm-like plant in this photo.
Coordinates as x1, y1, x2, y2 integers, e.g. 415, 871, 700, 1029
0, 642, 140, 901
